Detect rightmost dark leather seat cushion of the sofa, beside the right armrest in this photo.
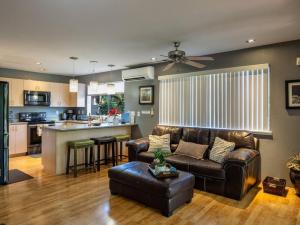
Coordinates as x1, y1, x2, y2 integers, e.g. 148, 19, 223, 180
189, 159, 225, 179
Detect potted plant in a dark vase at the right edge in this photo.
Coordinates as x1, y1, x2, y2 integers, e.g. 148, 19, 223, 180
287, 153, 300, 196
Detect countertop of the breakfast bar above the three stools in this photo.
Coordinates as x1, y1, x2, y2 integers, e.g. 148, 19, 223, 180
44, 123, 136, 131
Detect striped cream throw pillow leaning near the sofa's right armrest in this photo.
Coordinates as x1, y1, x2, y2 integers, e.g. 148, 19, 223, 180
209, 137, 235, 163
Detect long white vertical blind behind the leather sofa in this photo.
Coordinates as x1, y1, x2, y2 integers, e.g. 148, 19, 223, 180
159, 64, 270, 132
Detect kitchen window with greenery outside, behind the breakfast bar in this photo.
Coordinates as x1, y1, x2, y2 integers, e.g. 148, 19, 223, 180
87, 82, 125, 115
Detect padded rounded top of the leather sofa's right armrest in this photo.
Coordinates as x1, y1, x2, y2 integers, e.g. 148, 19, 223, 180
223, 148, 259, 167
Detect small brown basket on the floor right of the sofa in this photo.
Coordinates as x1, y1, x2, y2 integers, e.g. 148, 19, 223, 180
263, 177, 286, 196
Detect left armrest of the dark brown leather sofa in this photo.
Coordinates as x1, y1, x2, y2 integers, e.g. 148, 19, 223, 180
126, 138, 149, 161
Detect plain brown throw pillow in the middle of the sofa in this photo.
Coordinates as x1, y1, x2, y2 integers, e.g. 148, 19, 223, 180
175, 140, 208, 159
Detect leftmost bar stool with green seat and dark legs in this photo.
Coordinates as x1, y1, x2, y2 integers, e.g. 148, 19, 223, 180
66, 139, 96, 177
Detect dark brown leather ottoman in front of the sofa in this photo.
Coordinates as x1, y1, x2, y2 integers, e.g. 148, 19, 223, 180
108, 161, 195, 216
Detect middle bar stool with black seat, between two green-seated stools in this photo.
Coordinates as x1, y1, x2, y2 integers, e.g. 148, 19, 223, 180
91, 136, 116, 171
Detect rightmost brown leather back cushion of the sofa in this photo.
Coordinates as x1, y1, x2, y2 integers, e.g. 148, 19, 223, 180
210, 129, 256, 149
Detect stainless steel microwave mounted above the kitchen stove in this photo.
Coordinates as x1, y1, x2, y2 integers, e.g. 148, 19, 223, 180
24, 90, 51, 106
